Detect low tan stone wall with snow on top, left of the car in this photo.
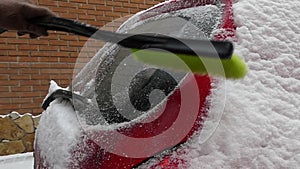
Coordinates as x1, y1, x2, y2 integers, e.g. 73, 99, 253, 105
0, 112, 40, 156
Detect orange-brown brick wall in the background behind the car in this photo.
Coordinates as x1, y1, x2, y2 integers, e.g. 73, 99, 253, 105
0, 0, 164, 115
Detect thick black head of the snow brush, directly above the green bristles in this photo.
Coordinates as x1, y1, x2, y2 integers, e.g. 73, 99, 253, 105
118, 34, 234, 59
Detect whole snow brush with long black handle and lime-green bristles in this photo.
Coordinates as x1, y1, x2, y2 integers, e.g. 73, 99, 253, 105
1, 17, 247, 79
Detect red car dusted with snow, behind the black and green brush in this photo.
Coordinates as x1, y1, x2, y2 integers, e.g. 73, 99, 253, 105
34, 0, 235, 169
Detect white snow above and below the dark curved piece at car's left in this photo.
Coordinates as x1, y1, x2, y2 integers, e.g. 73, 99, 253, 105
35, 81, 81, 169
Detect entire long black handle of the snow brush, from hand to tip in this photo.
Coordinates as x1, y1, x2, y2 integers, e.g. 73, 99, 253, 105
32, 17, 233, 59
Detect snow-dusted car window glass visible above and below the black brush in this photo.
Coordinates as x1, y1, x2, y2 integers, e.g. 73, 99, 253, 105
71, 5, 222, 124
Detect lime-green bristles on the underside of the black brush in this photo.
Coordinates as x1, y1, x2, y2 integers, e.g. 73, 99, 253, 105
132, 49, 247, 79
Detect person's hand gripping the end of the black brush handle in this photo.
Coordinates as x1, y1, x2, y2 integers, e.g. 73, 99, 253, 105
0, 0, 56, 38
